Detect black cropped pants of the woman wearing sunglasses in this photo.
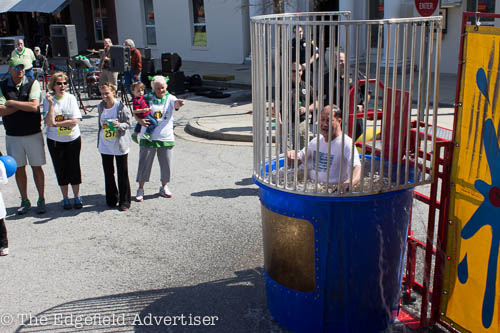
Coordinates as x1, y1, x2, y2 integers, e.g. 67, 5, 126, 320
47, 137, 82, 186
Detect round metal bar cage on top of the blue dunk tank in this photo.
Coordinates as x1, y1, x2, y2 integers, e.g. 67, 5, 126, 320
251, 12, 442, 196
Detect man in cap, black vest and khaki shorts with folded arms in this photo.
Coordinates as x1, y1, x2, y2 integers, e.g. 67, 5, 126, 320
0, 58, 46, 215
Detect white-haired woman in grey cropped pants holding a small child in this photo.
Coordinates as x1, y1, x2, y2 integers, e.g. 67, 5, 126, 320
135, 75, 184, 202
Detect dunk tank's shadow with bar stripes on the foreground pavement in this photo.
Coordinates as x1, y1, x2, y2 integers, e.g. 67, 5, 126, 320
16, 267, 283, 332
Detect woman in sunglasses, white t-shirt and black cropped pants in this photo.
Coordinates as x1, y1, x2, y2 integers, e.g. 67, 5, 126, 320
43, 72, 83, 209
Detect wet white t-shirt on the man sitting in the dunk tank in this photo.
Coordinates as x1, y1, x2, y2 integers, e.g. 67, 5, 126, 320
297, 135, 361, 183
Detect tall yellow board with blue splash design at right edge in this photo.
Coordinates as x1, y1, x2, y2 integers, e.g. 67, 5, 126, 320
441, 26, 500, 332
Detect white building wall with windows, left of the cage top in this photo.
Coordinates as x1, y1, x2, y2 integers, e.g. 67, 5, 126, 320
115, 0, 250, 64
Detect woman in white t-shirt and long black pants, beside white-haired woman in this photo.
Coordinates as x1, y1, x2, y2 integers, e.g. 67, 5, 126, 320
97, 82, 132, 211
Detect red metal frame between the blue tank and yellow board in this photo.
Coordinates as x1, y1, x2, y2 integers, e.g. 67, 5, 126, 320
403, 12, 500, 331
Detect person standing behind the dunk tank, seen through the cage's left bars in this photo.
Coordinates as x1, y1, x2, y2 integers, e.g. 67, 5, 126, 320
280, 62, 318, 149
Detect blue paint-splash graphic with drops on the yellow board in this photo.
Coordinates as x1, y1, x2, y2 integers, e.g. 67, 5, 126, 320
457, 105, 500, 328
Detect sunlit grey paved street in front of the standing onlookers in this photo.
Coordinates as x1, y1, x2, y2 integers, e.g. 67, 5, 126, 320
0, 91, 280, 332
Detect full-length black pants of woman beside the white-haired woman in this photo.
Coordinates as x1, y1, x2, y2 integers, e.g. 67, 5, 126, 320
101, 154, 130, 208
